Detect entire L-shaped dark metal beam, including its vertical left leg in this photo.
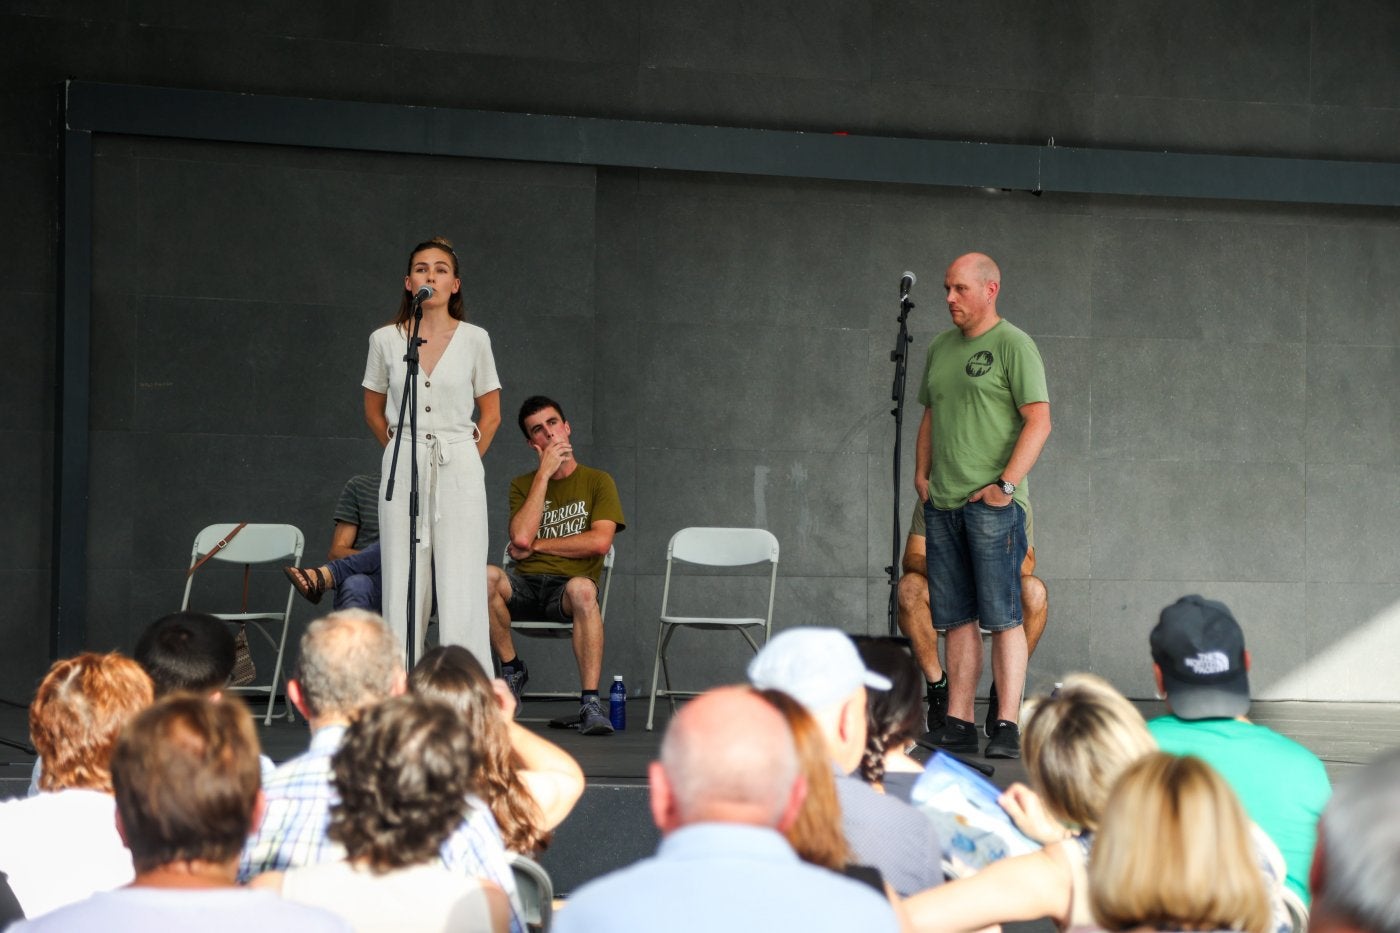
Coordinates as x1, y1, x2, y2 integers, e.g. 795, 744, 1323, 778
50, 81, 1400, 653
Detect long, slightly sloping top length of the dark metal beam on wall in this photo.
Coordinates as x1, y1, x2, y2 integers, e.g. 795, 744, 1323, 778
67, 81, 1400, 207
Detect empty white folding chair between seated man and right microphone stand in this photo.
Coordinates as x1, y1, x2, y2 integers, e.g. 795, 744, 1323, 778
647, 528, 778, 731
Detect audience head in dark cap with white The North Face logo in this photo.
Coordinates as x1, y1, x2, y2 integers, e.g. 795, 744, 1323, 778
1149, 595, 1249, 719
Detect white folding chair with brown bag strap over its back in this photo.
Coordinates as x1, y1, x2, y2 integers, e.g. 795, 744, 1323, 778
179, 523, 305, 726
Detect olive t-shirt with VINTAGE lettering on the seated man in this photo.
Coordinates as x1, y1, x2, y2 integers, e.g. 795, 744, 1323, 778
511, 464, 627, 583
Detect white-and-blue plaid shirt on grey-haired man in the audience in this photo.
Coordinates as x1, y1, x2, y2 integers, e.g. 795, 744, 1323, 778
238, 726, 525, 933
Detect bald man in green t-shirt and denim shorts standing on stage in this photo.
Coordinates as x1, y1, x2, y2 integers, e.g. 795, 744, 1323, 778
914, 252, 1050, 758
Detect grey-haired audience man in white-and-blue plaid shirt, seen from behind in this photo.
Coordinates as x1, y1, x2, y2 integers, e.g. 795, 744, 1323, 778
238, 609, 524, 933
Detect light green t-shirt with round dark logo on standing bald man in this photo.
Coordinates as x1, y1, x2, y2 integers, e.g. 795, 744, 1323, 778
918, 321, 1050, 509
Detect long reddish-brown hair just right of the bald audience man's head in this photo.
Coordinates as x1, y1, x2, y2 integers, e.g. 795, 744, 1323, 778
759, 691, 850, 871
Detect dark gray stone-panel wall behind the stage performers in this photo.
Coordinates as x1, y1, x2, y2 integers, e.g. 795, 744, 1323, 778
0, 0, 1400, 700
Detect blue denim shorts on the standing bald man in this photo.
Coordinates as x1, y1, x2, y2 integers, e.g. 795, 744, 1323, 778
924, 502, 1026, 632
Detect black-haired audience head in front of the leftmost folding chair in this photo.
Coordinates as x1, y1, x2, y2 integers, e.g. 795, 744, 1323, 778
134, 612, 238, 696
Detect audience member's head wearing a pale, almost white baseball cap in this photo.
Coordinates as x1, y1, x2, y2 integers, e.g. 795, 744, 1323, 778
749, 628, 890, 773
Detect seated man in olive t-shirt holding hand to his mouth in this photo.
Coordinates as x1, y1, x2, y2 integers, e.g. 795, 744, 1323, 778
487, 395, 627, 735
